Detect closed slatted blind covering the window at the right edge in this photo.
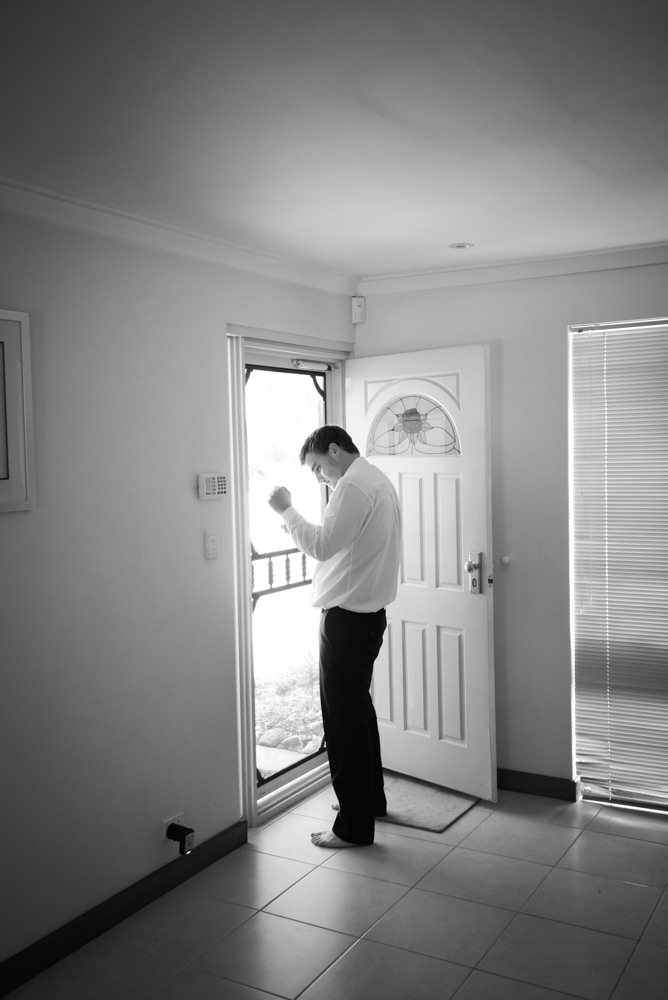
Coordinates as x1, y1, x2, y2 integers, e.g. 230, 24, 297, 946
570, 321, 668, 809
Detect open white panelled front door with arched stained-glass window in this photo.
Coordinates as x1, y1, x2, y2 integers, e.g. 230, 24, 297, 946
345, 345, 496, 801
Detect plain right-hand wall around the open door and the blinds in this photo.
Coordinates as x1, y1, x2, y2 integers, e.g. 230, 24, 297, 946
356, 265, 668, 778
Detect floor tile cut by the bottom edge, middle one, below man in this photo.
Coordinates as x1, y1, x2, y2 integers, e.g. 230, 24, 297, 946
300, 941, 468, 1000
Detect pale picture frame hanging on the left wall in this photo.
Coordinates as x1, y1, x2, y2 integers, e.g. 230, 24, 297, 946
0, 309, 35, 512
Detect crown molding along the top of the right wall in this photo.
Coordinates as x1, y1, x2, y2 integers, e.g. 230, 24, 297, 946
357, 243, 668, 296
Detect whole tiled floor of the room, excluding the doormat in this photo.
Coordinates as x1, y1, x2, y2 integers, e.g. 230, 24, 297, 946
5, 790, 668, 1000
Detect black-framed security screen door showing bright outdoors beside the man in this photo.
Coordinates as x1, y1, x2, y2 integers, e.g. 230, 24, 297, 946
245, 365, 326, 785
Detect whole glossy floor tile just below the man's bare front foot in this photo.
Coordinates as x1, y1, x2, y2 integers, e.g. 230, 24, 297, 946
266, 868, 406, 937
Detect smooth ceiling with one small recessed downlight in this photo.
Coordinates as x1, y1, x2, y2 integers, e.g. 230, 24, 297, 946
0, 0, 668, 278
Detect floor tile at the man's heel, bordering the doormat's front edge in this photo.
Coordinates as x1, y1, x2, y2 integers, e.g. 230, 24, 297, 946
323, 830, 452, 886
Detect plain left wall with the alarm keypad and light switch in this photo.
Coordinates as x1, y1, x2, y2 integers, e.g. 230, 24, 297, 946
0, 215, 352, 960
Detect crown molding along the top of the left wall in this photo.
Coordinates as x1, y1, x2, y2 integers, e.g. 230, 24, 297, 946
0, 178, 357, 295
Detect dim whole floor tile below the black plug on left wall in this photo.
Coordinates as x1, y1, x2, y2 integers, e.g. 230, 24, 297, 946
105, 893, 255, 962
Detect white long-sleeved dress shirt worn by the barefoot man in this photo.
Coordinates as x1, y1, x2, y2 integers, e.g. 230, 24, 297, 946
282, 457, 400, 612
